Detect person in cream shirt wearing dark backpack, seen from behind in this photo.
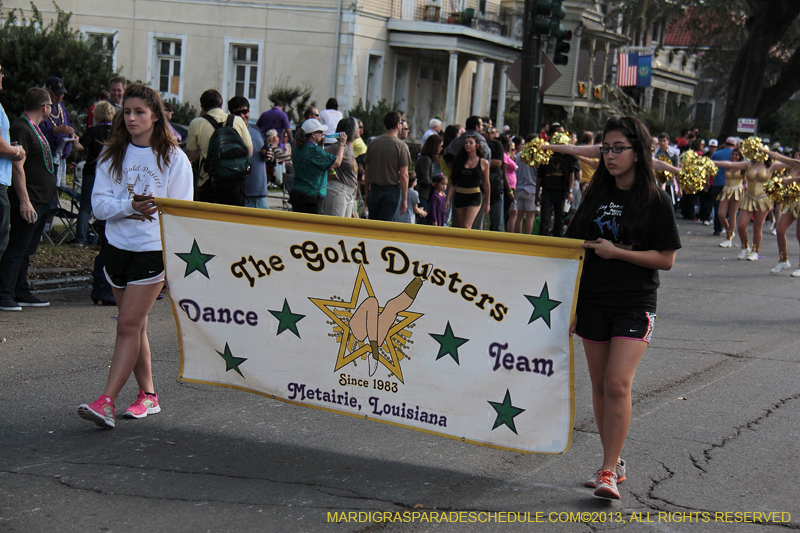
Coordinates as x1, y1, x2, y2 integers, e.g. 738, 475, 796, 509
186, 89, 253, 206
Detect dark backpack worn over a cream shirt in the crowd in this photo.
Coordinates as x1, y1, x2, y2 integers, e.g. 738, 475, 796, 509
203, 115, 251, 189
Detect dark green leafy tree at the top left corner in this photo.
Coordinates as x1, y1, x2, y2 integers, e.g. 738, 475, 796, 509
0, 3, 116, 127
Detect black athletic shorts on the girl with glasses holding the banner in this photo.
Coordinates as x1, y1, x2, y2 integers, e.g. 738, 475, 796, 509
575, 302, 656, 343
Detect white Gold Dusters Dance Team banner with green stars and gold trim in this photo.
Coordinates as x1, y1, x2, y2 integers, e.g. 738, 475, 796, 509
156, 198, 583, 453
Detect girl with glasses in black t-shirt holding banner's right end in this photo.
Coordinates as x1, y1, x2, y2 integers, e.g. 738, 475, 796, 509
559, 117, 681, 499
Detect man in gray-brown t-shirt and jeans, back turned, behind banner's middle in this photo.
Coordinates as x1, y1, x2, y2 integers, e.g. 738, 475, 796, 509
364, 111, 411, 221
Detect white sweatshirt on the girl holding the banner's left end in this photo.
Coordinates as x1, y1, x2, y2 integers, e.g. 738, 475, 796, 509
92, 144, 194, 252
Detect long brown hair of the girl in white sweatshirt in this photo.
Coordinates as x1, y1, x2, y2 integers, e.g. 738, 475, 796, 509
98, 83, 178, 179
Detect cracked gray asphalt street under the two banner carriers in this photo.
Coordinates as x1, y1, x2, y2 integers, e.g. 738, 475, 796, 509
0, 217, 800, 533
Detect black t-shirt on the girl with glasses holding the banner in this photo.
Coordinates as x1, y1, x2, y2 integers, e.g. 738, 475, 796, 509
566, 188, 681, 311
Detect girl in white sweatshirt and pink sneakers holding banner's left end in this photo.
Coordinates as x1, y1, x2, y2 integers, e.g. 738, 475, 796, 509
78, 84, 192, 429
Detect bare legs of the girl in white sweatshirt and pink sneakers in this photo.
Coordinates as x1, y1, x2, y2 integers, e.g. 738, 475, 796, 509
103, 283, 163, 401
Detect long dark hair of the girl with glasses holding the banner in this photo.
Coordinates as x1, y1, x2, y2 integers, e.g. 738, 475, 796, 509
572, 117, 660, 245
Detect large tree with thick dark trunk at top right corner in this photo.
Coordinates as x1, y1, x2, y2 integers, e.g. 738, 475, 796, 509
608, 0, 800, 135
